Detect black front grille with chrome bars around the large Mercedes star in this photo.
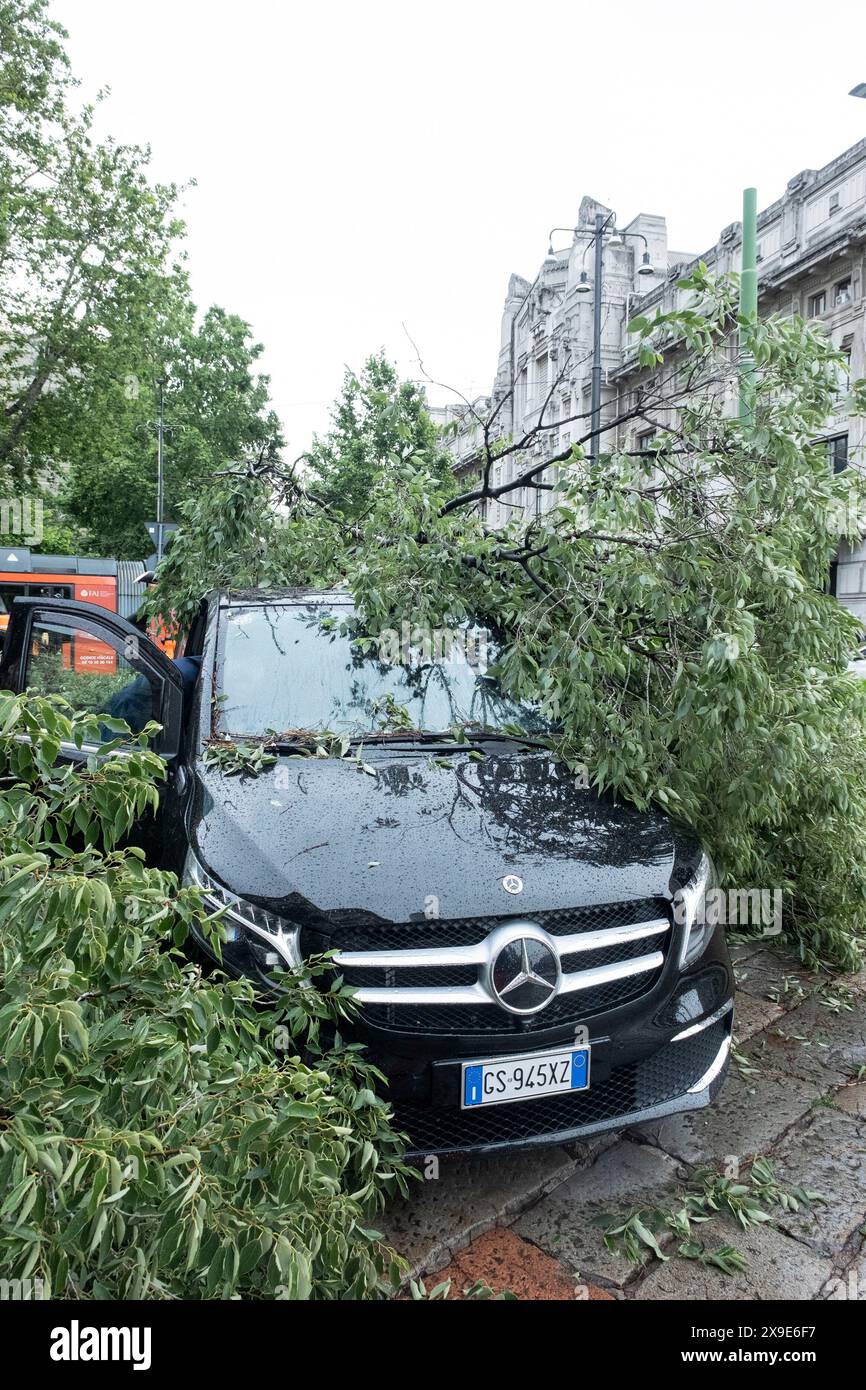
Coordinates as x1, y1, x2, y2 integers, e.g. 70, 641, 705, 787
323, 899, 670, 1033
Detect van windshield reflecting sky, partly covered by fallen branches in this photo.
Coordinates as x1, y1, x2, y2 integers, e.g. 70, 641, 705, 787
218, 603, 549, 738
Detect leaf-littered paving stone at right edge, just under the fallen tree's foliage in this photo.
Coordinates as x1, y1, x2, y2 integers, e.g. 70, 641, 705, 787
741, 994, 866, 1090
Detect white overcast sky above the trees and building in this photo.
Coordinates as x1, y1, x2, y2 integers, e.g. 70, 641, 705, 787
53, 0, 866, 452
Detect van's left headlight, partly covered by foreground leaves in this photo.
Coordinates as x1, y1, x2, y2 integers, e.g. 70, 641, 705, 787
183, 851, 302, 987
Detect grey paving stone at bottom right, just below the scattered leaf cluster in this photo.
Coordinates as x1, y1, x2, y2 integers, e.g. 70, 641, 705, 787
628, 1218, 833, 1302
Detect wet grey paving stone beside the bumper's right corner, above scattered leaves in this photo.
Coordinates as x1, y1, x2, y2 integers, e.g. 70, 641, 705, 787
634, 1066, 822, 1165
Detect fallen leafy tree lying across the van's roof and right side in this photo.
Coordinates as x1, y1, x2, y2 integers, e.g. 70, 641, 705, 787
152, 267, 866, 967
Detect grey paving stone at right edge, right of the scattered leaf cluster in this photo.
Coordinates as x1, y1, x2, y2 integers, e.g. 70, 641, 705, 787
770, 1106, 866, 1255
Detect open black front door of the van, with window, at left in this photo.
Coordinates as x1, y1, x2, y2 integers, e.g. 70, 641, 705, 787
0, 598, 183, 760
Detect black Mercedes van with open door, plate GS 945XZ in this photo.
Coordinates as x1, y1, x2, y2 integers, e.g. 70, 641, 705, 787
0, 589, 733, 1154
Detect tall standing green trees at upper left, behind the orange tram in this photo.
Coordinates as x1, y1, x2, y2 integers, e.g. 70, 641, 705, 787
0, 0, 282, 559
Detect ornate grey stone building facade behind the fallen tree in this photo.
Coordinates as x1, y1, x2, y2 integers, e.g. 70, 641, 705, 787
432, 140, 866, 626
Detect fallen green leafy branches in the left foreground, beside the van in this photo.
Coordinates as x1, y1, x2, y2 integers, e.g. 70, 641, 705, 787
0, 695, 407, 1300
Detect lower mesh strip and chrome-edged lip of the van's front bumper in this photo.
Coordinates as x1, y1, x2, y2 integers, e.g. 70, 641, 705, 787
395, 1002, 733, 1158
